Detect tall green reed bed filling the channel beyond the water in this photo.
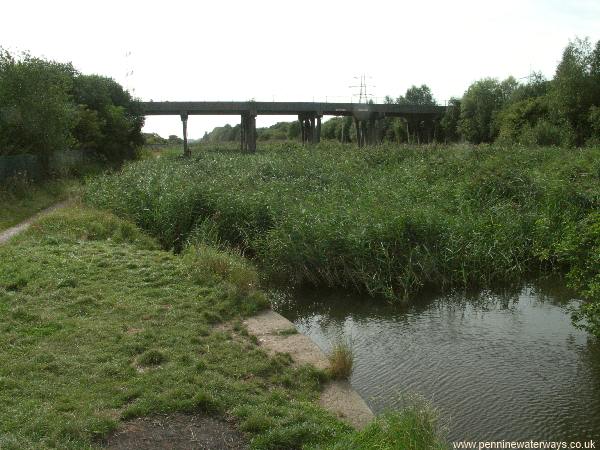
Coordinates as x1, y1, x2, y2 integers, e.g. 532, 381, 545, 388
86, 143, 600, 331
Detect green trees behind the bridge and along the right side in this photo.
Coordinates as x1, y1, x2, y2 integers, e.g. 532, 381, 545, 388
203, 38, 600, 147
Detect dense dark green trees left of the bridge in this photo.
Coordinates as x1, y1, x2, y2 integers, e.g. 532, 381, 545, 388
0, 48, 144, 174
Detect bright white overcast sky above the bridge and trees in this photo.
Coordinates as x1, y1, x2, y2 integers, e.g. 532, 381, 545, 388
0, 0, 600, 138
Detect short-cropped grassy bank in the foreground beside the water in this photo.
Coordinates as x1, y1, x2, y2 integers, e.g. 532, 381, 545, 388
0, 208, 436, 449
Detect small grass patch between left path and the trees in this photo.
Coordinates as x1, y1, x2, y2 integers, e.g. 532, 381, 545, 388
0, 179, 80, 231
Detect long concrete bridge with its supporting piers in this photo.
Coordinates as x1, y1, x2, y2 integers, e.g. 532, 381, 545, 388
141, 101, 446, 155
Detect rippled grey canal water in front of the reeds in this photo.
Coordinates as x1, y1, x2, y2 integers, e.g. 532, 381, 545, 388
273, 283, 600, 445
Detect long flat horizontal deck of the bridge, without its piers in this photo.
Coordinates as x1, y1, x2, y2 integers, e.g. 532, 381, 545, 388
141, 102, 446, 117
